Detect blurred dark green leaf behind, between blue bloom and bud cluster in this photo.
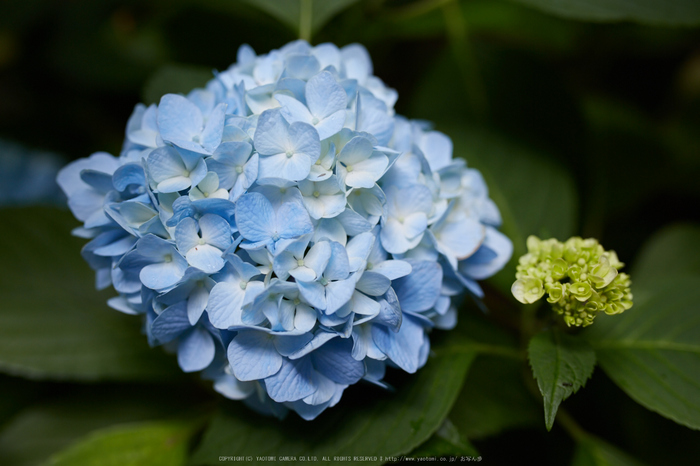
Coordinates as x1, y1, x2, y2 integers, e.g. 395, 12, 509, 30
448, 126, 578, 294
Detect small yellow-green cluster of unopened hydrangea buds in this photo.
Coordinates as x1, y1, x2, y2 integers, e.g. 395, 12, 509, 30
511, 236, 632, 327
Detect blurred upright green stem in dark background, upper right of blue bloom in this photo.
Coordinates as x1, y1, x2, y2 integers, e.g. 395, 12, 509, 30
442, 0, 488, 119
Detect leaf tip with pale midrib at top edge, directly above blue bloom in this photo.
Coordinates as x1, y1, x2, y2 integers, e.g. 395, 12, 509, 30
243, 0, 358, 32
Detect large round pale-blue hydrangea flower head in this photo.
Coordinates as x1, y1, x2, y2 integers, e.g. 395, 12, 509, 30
58, 41, 512, 419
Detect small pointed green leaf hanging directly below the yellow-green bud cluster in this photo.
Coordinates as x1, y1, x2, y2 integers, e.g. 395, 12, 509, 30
527, 329, 595, 430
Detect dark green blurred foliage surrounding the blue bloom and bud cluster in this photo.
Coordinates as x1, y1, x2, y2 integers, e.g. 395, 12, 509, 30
0, 0, 700, 465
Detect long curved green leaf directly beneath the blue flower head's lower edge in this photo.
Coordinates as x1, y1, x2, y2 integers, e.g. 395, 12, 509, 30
193, 332, 476, 465
